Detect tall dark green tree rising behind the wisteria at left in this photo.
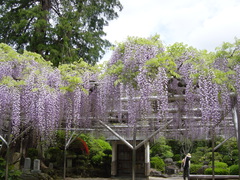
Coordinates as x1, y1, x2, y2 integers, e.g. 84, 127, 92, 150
0, 0, 122, 66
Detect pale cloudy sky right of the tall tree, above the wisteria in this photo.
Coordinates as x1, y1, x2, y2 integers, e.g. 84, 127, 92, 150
100, 0, 240, 62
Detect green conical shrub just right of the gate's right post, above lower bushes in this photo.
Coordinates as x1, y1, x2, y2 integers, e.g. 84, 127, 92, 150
150, 136, 173, 159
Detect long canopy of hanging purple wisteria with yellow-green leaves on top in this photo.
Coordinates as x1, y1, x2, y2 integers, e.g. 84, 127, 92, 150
0, 36, 240, 144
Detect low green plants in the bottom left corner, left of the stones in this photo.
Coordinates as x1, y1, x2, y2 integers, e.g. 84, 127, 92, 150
0, 157, 22, 180
